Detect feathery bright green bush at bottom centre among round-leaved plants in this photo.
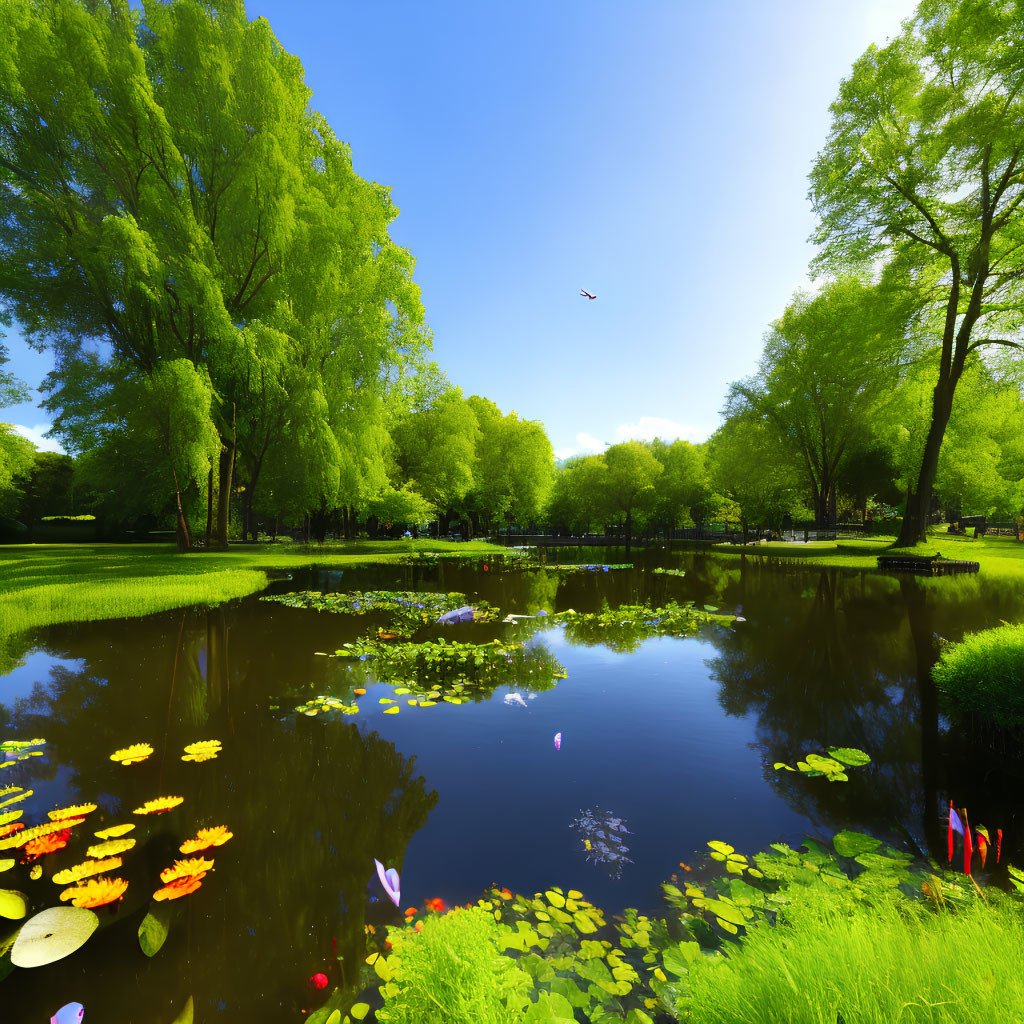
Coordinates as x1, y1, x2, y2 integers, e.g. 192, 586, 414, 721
377, 907, 532, 1024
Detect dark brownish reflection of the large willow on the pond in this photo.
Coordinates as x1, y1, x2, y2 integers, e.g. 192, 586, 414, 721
4, 609, 437, 1022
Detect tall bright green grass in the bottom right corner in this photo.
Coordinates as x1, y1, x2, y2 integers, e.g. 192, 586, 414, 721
677, 888, 1024, 1024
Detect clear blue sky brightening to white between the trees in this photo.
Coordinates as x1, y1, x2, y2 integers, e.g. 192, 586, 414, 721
0, 0, 914, 456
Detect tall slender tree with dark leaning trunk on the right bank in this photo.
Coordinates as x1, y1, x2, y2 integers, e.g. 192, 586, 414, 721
810, 0, 1024, 545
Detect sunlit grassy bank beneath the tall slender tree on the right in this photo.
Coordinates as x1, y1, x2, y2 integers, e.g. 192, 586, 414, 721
712, 531, 1024, 577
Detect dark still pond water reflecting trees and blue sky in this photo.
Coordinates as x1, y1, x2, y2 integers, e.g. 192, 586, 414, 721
0, 549, 1024, 1024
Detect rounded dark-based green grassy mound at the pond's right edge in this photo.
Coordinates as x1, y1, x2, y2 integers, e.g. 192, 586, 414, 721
932, 624, 1024, 728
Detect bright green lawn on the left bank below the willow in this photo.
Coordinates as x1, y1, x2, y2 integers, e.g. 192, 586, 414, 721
0, 541, 504, 636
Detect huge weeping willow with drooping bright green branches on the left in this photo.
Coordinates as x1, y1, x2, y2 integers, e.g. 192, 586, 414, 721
0, 0, 428, 544
